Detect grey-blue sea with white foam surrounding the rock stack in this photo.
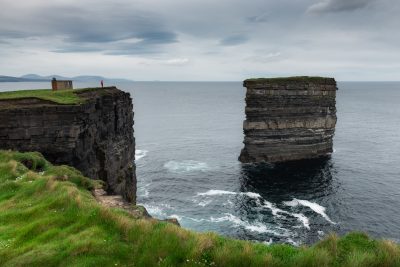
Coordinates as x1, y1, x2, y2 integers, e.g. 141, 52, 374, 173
0, 82, 400, 247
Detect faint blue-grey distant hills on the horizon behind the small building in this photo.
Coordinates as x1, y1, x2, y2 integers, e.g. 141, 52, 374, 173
0, 74, 131, 82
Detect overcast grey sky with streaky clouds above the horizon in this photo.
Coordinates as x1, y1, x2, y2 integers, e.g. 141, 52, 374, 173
0, 0, 400, 81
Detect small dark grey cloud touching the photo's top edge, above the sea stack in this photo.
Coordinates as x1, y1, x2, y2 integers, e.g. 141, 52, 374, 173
308, 0, 375, 13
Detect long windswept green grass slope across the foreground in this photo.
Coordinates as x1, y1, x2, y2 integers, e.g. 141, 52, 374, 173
0, 151, 400, 267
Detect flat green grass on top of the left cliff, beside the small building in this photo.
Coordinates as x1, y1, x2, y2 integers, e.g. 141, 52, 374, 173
0, 88, 106, 105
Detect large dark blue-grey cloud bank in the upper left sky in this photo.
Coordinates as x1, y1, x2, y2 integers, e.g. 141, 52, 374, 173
0, 3, 178, 54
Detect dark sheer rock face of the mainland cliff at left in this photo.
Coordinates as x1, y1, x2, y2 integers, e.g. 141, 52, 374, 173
0, 87, 136, 202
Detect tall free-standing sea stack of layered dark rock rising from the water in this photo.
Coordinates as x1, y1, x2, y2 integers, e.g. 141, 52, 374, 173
239, 77, 337, 163
